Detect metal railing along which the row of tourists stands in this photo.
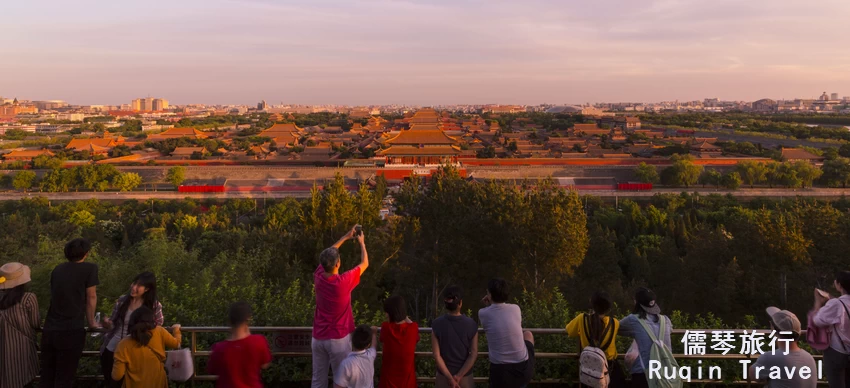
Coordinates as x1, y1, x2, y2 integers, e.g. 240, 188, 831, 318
36, 326, 827, 387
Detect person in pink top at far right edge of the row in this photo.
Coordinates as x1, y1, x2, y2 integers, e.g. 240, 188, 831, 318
812, 271, 850, 388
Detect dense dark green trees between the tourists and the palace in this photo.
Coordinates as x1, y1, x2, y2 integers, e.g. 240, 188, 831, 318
0, 170, 850, 381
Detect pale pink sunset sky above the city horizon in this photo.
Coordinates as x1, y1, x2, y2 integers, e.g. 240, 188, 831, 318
0, 0, 850, 105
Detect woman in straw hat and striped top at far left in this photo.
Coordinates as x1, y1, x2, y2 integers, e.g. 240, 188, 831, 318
0, 263, 41, 388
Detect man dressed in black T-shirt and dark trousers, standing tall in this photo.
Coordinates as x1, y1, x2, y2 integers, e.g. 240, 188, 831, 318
39, 238, 100, 388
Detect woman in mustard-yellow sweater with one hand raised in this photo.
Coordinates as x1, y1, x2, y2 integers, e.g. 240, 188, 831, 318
112, 306, 180, 388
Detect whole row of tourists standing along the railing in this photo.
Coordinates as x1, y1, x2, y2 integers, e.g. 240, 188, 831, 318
0, 227, 850, 388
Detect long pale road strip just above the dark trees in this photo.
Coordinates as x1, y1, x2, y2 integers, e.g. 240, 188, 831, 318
0, 187, 850, 201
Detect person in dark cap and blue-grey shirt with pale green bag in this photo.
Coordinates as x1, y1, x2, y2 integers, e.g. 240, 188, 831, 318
619, 287, 682, 388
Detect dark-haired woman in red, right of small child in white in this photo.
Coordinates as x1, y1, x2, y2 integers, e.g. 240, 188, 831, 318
378, 296, 419, 388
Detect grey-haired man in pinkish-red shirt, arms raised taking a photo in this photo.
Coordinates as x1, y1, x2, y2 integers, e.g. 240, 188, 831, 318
311, 226, 369, 388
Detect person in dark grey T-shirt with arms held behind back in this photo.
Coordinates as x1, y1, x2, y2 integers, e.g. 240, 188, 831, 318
431, 286, 478, 388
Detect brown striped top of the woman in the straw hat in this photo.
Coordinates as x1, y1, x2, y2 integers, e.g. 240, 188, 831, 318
0, 291, 40, 388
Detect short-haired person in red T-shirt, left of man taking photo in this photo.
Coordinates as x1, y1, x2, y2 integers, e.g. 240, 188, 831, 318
207, 302, 272, 388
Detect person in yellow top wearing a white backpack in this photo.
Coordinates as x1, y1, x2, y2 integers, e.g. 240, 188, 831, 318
567, 291, 626, 388
